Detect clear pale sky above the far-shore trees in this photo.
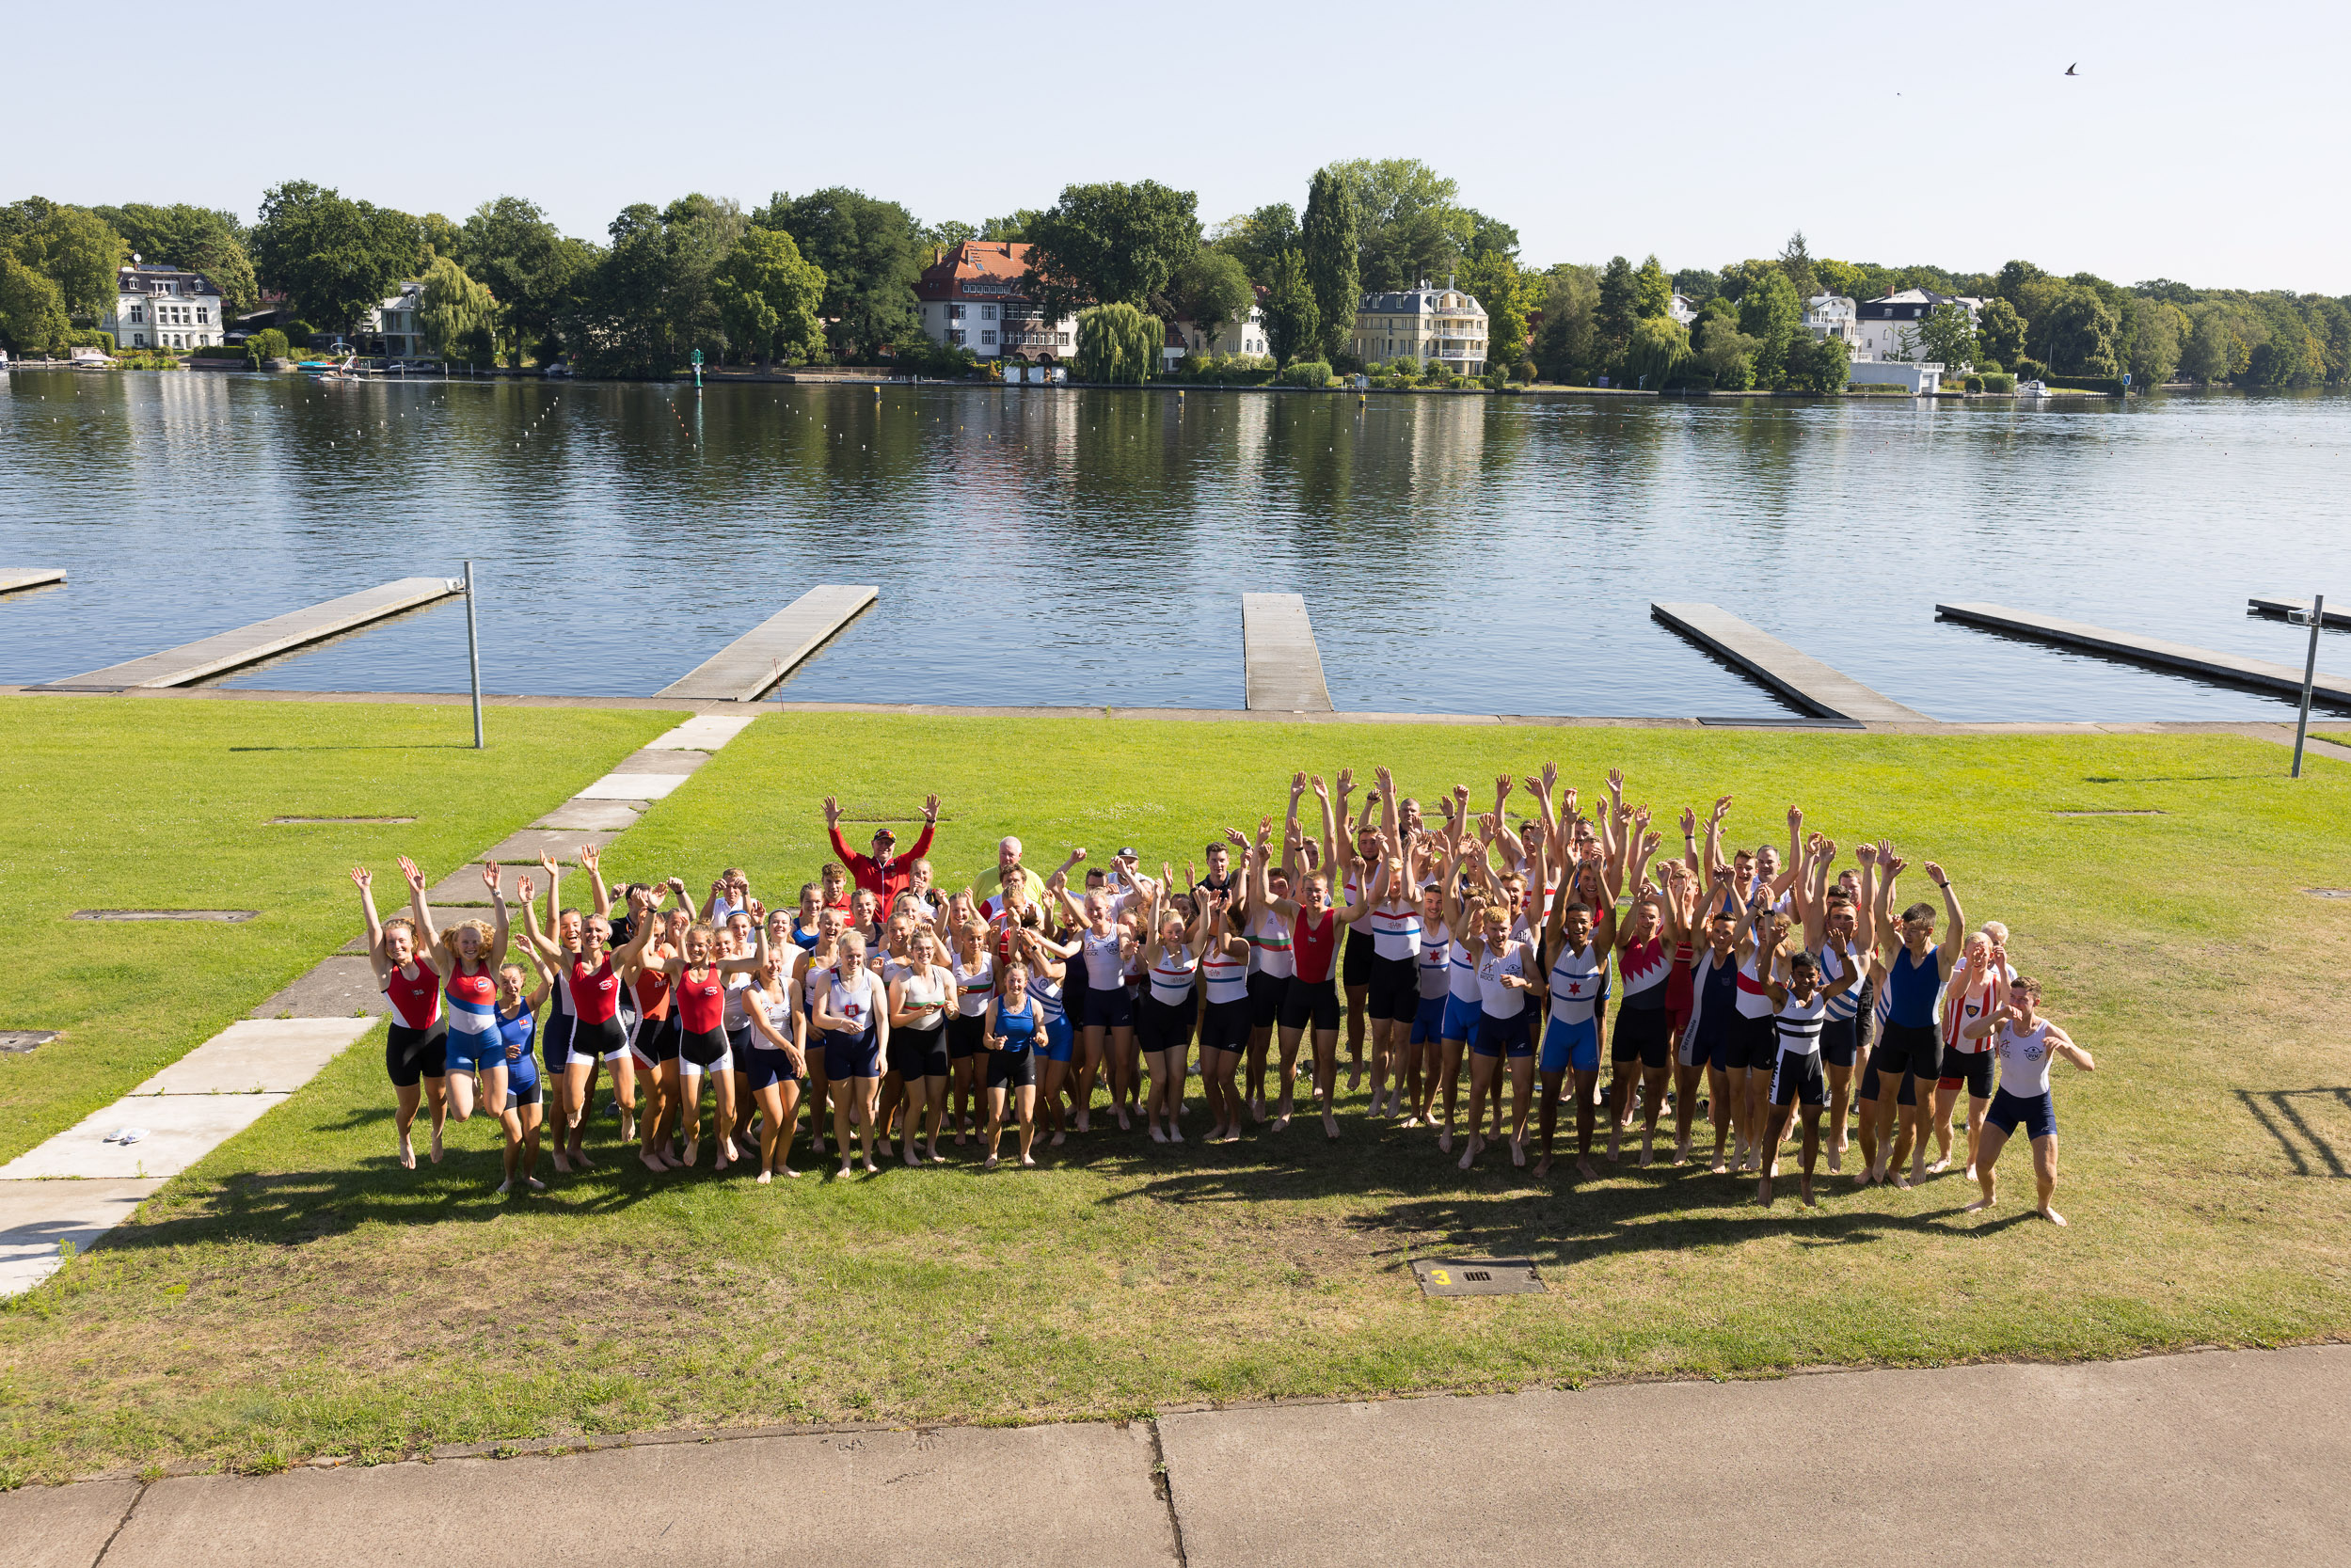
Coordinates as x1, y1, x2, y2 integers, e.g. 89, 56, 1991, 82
0, 0, 2351, 293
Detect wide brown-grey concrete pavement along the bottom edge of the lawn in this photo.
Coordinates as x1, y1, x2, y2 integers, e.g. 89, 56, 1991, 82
0, 1345, 2351, 1568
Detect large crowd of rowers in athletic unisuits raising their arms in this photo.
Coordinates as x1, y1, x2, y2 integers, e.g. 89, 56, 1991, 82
353, 764, 2092, 1225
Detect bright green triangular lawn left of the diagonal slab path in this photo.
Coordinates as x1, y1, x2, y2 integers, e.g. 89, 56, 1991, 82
0, 698, 679, 1162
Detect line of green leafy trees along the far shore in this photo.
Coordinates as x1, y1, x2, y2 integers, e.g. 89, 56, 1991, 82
0, 180, 2351, 390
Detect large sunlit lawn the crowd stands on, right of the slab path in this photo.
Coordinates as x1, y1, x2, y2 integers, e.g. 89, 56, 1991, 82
0, 707, 2351, 1479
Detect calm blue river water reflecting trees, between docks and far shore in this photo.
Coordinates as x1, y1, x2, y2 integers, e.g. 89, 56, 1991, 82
0, 372, 2351, 720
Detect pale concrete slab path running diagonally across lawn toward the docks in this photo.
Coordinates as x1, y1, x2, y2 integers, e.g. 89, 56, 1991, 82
0, 712, 759, 1297
